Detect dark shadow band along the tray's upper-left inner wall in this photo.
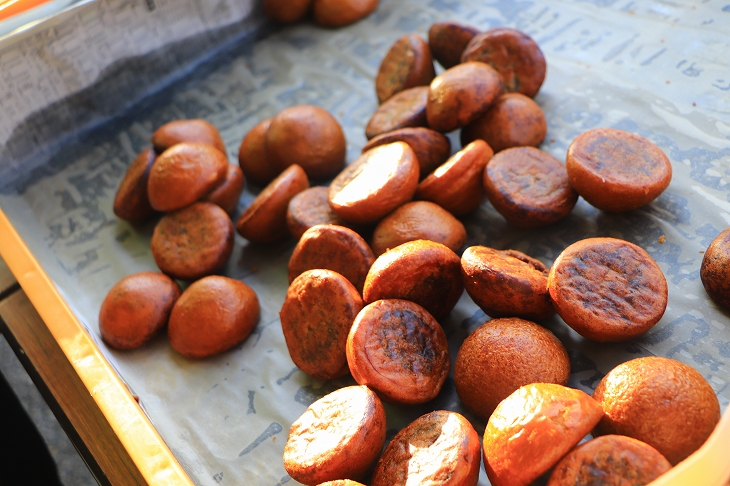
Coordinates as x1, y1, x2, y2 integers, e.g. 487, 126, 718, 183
0, 6, 272, 195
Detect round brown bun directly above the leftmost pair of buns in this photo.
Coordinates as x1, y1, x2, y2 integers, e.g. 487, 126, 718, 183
150, 201, 233, 280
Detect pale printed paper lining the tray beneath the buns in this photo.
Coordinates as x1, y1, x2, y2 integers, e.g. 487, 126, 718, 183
0, 0, 730, 485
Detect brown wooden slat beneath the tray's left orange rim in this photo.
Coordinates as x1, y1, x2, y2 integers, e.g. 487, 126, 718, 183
0, 290, 147, 485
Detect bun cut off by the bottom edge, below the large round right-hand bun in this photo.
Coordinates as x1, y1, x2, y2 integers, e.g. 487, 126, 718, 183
547, 435, 672, 486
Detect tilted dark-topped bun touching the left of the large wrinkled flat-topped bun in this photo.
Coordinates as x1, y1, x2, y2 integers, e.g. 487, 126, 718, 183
461, 246, 555, 320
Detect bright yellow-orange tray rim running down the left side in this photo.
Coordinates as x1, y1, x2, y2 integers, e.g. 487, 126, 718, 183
0, 209, 193, 485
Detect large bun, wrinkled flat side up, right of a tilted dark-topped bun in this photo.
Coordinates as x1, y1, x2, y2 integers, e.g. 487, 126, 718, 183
548, 238, 668, 342
